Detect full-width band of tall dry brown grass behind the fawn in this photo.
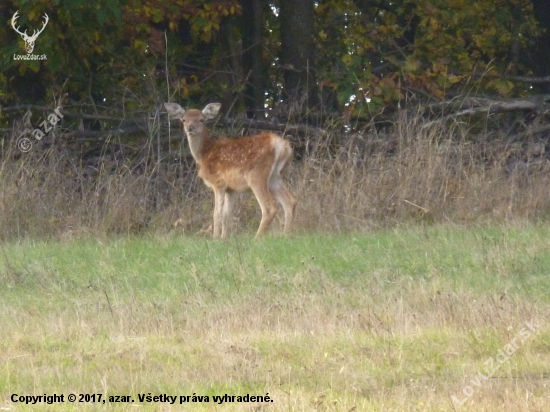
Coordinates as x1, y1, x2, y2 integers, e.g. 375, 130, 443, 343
0, 108, 550, 240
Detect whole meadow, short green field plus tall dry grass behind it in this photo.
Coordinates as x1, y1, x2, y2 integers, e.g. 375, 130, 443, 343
0, 112, 550, 412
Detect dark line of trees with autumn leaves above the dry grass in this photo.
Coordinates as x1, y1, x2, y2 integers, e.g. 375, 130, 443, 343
0, 0, 550, 124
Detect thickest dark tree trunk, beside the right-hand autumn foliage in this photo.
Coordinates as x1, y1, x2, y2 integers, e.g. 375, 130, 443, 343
279, 0, 318, 112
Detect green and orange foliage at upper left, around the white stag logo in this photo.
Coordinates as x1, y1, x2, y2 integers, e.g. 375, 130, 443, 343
0, 0, 239, 103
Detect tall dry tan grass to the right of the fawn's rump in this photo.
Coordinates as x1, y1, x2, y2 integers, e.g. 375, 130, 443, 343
294, 110, 550, 230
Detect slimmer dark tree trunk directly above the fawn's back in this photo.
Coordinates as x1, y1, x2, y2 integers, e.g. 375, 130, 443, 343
242, 0, 266, 117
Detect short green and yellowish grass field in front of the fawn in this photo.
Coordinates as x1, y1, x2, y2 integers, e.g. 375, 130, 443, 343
0, 224, 550, 411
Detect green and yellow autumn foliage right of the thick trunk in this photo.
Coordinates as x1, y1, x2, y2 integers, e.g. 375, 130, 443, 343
316, 0, 539, 111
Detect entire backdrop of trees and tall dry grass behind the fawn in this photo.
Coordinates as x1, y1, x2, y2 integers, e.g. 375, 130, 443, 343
0, 0, 550, 237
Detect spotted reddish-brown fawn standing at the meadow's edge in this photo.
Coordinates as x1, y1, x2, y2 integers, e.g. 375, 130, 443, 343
164, 103, 296, 239
